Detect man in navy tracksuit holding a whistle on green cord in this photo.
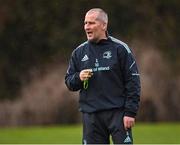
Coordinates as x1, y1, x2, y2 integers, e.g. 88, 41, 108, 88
65, 8, 140, 144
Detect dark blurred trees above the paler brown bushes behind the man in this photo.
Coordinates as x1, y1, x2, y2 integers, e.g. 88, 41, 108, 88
0, 0, 180, 103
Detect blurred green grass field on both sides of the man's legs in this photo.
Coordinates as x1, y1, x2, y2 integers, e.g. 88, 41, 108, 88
0, 123, 180, 144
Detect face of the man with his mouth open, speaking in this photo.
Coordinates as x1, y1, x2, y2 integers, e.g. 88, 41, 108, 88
84, 12, 106, 42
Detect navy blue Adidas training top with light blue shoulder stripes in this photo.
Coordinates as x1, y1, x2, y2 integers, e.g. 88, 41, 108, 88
65, 36, 140, 117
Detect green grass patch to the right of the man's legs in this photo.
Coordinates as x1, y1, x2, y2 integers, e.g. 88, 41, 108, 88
133, 123, 180, 144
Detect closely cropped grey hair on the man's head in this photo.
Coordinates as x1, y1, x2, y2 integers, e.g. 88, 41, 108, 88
87, 8, 108, 24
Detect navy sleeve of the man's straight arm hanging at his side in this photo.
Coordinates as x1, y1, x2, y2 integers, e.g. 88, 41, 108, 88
120, 48, 141, 117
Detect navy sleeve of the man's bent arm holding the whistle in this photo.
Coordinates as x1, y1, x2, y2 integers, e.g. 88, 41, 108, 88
65, 51, 82, 91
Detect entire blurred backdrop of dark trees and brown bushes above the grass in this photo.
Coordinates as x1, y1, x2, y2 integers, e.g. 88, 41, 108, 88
0, 0, 180, 125
